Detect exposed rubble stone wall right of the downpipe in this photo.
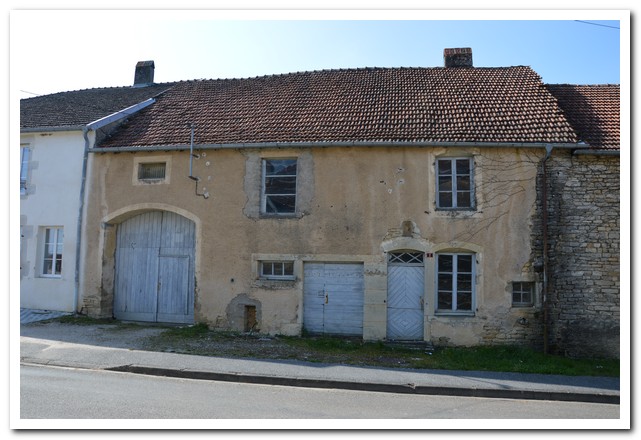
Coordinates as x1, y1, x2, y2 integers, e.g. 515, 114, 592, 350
548, 152, 620, 358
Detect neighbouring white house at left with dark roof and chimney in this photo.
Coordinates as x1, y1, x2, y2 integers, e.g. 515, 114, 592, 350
20, 61, 171, 312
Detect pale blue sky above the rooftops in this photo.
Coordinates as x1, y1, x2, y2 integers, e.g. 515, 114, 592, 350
10, 10, 629, 98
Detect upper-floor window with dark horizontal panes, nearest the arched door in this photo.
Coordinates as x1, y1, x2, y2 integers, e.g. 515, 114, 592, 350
261, 159, 296, 215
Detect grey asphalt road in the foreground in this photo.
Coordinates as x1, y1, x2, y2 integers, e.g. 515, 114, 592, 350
20, 365, 620, 428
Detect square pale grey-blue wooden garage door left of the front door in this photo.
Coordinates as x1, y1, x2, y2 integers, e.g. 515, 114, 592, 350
303, 263, 363, 336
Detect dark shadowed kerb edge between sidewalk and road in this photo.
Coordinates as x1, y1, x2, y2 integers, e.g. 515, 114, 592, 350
104, 365, 620, 405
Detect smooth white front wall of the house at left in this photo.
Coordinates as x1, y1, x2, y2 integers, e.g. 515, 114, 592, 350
20, 131, 85, 312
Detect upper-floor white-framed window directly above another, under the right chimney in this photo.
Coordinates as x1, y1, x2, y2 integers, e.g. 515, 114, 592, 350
436, 157, 474, 209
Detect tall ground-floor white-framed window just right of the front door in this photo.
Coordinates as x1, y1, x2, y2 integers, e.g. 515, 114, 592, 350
436, 254, 476, 313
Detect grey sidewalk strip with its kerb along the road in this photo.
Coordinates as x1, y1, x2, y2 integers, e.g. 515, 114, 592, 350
20, 336, 620, 404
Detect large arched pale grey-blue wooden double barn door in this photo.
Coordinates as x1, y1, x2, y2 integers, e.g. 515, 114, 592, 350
114, 211, 196, 323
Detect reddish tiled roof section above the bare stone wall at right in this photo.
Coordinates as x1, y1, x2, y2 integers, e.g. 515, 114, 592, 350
547, 84, 620, 150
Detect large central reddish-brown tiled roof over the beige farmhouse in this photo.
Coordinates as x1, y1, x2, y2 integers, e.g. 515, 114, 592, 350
100, 67, 577, 147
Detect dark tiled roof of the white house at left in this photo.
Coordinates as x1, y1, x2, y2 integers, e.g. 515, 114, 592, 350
20, 83, 172, 129
